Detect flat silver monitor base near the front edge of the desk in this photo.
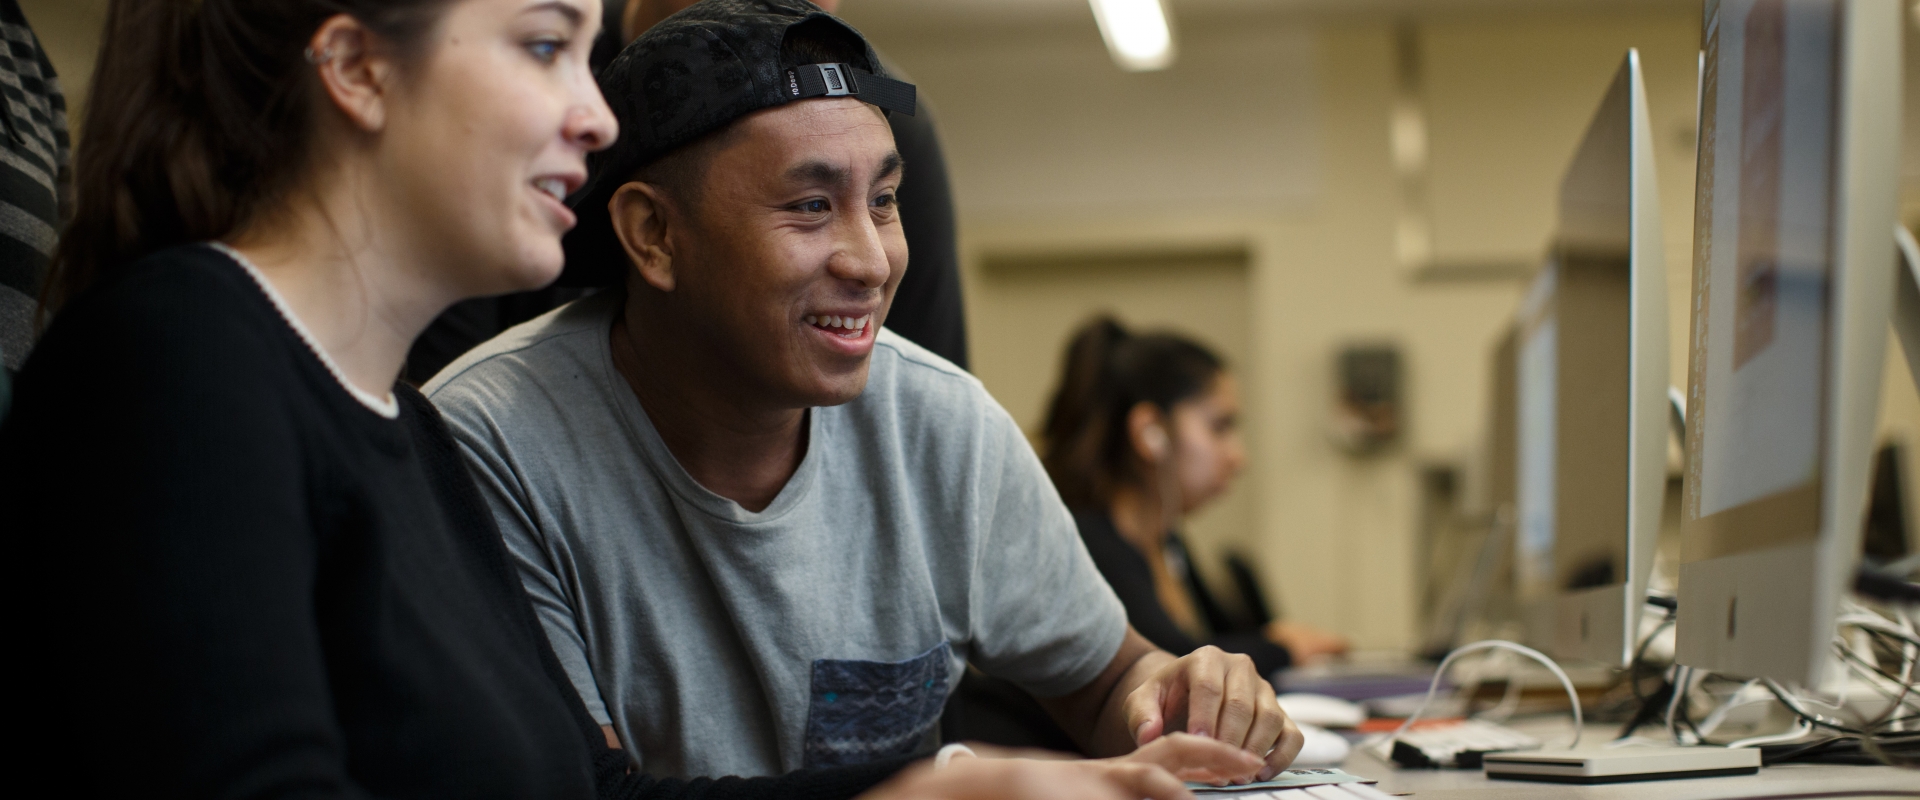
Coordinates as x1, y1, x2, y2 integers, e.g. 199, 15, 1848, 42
1482, 746, 1761, 783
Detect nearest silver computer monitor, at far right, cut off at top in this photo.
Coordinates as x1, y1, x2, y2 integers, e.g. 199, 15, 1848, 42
1676, 0, 1903, 687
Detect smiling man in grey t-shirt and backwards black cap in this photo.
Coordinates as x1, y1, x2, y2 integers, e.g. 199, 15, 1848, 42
426, 0, 1300, 777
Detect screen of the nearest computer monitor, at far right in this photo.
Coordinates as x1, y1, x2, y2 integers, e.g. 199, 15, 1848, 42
1684, 0, 1839, 560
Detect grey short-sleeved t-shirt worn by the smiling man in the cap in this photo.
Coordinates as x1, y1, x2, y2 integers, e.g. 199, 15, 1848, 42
426, 292, 1127, 777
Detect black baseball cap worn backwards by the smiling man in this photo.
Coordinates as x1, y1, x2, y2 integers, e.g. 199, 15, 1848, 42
559, 0, 916, 286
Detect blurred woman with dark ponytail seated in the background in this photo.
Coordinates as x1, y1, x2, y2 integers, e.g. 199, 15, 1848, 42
1041, 317, 1348, 675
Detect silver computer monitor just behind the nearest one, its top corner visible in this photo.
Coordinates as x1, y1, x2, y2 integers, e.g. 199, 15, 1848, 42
1515, 50, 1668, 666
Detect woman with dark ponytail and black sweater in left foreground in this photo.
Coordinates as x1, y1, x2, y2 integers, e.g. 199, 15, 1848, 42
0, 0, 1258, 800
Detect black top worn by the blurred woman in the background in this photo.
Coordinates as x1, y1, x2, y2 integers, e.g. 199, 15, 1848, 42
1073, 508, 1294, 677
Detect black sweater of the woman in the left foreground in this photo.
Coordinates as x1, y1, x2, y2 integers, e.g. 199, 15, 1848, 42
0, 246, 900, 798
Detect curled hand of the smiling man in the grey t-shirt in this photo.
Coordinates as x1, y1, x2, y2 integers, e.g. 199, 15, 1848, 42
1125, 647, 1306, 781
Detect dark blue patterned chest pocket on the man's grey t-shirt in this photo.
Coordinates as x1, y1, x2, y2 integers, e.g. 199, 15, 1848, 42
806, 641, 952, 767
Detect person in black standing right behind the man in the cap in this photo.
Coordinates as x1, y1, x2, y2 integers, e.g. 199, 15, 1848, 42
407, 0, 968, 384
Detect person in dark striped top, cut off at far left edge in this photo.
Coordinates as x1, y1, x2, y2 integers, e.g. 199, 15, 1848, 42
0, 0, 71, 383
